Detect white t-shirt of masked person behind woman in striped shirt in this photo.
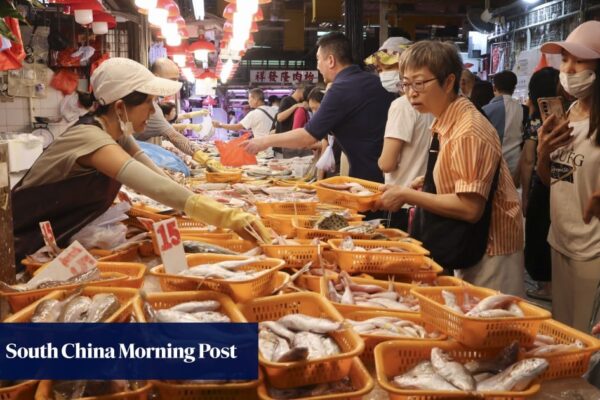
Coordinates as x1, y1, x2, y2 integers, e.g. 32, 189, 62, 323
385, 96, 433, 186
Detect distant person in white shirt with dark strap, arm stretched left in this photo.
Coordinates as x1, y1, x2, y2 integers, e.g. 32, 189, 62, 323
213, 89, 275, 138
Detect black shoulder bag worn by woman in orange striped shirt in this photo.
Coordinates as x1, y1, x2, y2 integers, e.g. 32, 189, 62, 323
411, 133, 502, 270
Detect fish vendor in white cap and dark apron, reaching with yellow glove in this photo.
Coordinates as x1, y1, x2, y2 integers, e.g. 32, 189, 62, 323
12, 58, 268, 265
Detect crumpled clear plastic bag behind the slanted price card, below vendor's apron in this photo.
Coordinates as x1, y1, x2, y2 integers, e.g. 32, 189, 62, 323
71, 202, 131, 250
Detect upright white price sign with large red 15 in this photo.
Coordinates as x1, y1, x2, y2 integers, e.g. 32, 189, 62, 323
152, 218, 187, 274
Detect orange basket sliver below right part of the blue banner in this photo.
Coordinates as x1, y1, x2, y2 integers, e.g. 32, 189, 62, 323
152, 379, 261, 400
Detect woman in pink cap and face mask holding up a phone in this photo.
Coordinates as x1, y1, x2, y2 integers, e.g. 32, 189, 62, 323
537, 21, 600, 330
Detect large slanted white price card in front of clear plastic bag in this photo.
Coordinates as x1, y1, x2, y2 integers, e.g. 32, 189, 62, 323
27, 241, 98, 286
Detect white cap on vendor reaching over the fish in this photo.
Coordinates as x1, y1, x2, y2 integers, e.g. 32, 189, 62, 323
90, 57, 182, 105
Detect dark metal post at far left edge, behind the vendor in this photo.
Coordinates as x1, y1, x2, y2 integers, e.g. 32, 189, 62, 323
0, 142, 15, 284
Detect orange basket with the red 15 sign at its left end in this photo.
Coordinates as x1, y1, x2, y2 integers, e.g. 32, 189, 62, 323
150, 254, 285, 302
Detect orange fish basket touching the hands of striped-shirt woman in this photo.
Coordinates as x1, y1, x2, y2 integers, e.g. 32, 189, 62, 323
313, 176, 381, 211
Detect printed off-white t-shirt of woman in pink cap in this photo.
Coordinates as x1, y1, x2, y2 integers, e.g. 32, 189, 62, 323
548, 119, 600, 260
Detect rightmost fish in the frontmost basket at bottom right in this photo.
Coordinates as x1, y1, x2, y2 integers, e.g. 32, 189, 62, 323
477, 358, 550, 392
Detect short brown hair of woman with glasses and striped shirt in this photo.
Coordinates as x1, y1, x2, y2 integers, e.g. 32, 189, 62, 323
399, 40, 463, 93
